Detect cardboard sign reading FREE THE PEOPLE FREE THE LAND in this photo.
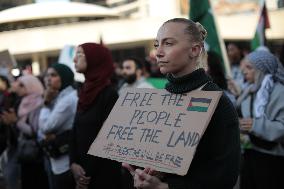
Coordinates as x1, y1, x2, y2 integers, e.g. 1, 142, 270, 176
88, 88, 222, 175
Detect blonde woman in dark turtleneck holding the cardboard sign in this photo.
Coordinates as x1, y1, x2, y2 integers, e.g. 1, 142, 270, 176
123, 18, 240, 189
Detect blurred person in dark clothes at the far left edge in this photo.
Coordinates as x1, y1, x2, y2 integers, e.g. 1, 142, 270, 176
0, 76, 21, 189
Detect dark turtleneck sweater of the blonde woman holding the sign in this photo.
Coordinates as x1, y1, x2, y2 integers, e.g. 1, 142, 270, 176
163, 69, 240, 189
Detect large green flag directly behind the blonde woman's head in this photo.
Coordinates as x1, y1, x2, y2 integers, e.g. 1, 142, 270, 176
190, 0, 230, 75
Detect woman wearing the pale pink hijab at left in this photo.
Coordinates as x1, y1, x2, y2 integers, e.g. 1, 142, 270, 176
16, 75, 48, 189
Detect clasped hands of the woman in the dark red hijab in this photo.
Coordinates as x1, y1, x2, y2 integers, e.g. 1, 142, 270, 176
71, 163, 91, 189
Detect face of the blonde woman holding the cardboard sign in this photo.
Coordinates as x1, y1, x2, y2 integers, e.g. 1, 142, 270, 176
154, 22, 200, 77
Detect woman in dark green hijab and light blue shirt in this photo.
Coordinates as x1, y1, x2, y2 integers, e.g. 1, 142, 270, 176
39, 63, 78, 189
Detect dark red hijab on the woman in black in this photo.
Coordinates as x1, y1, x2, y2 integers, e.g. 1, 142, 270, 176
78, 43, 114, 111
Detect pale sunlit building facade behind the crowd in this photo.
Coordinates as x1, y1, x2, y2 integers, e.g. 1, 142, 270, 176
0, 0, 284, 74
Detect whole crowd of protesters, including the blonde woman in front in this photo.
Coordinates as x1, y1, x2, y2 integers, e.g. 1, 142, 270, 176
0, 18, 284, 189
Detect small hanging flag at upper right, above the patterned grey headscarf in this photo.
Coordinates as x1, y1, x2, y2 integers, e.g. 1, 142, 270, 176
251, 1, 270, 50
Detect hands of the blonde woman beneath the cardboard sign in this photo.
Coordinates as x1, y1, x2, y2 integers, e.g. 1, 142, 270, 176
122, 163, 166, 189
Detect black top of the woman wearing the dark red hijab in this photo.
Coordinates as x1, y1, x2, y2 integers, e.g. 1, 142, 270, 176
70, 86, 121, 189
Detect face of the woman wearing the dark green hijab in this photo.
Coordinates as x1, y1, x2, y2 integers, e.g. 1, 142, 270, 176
45, 68, 61, 90
